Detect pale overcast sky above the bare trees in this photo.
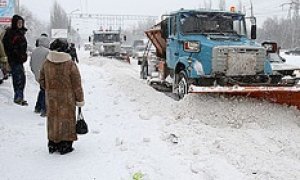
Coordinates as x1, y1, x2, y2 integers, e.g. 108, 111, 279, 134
20, 0, 290, 22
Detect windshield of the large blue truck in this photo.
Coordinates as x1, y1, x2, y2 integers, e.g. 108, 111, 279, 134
180, 12, 246, 35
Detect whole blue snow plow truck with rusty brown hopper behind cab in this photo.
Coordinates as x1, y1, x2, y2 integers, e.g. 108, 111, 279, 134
141, 9, 294, 98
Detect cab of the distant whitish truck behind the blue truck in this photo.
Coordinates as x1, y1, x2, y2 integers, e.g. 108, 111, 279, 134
89, 30, 121, 56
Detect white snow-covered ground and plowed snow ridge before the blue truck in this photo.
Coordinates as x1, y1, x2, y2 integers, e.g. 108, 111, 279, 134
0, 52, 300, 180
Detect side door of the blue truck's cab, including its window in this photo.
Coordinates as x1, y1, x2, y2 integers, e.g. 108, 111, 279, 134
166, 16, 179, 70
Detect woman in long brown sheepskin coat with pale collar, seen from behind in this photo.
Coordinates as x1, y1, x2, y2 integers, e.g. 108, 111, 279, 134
39, 39, 84, 154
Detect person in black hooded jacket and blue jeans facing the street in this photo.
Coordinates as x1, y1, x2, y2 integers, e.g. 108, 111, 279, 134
3, 15, 28, 106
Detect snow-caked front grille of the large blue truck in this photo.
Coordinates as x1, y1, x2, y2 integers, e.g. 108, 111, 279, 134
212, 47, 265, 76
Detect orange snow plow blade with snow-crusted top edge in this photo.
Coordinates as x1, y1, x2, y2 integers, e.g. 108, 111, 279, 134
189, 85, 300, 110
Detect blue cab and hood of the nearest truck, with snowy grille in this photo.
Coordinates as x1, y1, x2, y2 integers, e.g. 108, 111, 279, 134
155, 9, 281, 93
